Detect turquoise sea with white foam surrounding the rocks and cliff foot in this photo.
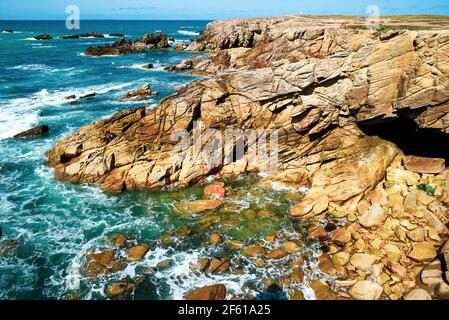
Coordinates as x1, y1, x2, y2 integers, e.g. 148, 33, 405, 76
0, 21, 317, 299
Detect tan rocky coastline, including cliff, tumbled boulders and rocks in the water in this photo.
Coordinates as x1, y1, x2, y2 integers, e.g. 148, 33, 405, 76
47, 16, 449, 300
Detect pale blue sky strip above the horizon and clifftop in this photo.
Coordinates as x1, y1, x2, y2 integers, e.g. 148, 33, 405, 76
0, 0, 449, 20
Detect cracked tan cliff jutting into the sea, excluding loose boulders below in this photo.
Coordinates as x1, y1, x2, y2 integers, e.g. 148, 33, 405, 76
48, 18, 449, 210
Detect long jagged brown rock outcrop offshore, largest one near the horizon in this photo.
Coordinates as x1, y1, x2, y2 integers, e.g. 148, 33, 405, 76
84, 33, 170, 56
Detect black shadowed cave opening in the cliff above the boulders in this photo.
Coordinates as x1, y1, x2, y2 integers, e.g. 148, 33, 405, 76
358, 116, 449, 162
